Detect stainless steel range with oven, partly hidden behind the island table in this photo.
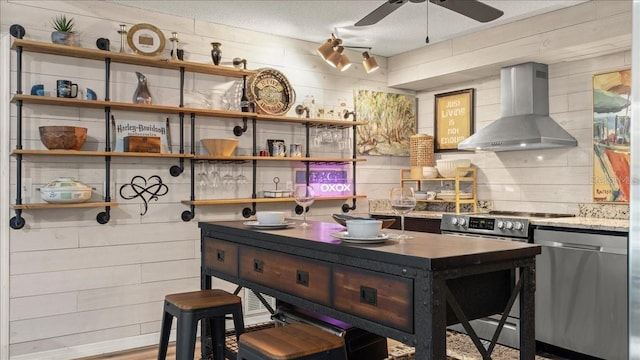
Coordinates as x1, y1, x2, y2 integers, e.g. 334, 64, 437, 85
440, 211, 574, 349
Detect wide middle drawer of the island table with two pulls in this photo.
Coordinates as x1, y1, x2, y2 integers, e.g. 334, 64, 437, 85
240, 247, 331, 305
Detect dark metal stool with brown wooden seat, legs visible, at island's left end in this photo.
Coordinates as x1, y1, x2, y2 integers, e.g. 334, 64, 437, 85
158, 289, 244, 360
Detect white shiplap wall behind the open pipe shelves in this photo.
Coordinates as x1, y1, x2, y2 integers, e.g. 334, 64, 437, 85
0, 0, 408, 359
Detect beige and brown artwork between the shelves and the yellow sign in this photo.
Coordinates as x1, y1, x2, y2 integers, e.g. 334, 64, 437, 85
354, 90, 417, 156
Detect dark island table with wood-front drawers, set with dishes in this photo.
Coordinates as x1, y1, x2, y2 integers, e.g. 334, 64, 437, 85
199, 221, 540, 360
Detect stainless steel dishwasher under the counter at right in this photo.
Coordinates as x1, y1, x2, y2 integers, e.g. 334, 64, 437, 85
533, 227, 628, 360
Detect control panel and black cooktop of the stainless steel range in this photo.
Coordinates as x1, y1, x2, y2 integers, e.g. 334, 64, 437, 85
440, 211, 574, 242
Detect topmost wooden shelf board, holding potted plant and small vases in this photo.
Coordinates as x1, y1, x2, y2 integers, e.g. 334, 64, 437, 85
11, 39, 256, 78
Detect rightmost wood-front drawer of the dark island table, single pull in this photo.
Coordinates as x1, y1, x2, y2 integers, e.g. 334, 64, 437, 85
333, 266, 413, 333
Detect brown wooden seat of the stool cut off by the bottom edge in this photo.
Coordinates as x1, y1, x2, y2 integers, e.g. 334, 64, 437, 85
237, 323, 347, 360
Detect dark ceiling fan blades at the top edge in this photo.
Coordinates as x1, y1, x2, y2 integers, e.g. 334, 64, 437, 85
355, 0, 504, 26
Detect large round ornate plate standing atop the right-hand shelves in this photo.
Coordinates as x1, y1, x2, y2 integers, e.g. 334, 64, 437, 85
247, 68, 296, 115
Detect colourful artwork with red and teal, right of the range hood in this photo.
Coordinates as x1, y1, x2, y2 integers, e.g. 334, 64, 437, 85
593, 70, 631, 203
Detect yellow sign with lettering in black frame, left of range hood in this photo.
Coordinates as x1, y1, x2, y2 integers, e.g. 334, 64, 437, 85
433, 89, 475, 152
